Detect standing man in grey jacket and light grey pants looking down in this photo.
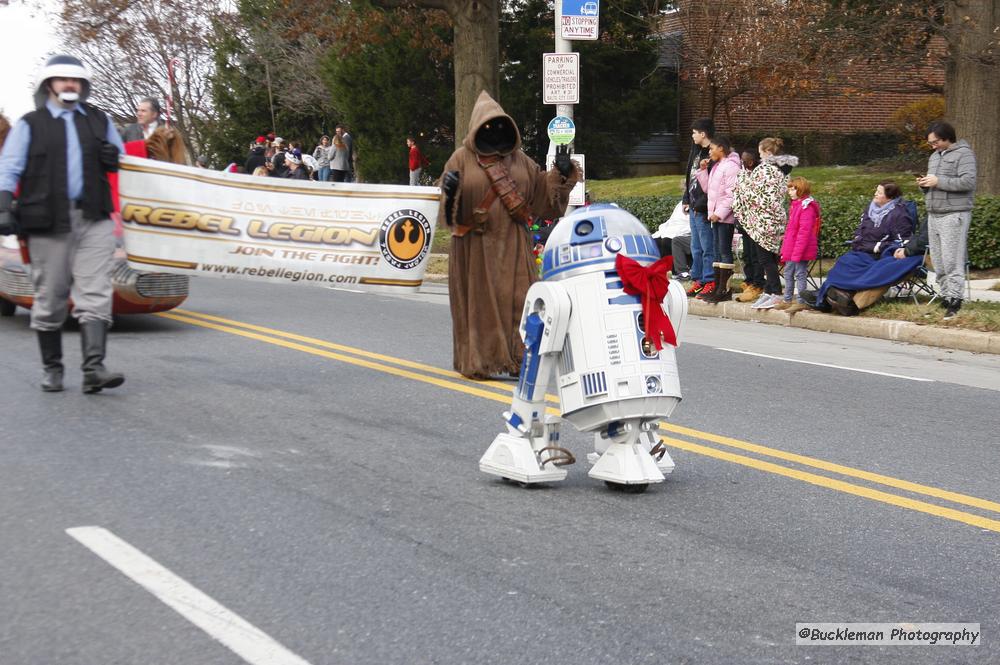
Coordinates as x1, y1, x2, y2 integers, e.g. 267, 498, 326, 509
917, 121, 976, 319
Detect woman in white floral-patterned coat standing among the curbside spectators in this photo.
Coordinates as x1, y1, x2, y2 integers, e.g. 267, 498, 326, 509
733, 137, 799, 309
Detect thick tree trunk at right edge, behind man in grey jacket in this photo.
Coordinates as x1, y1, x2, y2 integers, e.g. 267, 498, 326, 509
945, 0, 1000, 194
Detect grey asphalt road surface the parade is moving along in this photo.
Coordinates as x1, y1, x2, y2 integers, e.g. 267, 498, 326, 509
0, 272, 1000, 665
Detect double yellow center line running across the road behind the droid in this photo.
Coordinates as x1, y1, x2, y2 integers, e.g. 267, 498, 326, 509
158, 309, 1000, 533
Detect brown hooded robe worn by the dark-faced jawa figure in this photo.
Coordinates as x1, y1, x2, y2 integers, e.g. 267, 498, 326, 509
438, 92, 579, 379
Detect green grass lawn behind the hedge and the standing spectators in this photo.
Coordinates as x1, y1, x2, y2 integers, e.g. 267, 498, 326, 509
587, 166, 920, 201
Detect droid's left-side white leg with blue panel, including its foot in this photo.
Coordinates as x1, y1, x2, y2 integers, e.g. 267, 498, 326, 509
479, 284, 576, 483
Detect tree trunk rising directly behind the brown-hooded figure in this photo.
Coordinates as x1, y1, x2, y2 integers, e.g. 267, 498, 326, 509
448, 0, 500, 146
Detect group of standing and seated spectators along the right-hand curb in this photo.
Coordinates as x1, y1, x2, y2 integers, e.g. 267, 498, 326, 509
654, 118, 976, 319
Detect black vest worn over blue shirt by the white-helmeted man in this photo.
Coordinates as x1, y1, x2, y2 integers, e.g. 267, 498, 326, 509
17, 104, 114, 234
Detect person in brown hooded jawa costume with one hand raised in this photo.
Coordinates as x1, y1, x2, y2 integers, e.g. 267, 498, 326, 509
438, 91, 580, 379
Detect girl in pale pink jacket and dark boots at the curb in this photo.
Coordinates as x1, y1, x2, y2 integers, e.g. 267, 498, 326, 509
697, 136, 742, 302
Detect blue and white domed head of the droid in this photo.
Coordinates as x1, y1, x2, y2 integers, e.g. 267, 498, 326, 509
542, 203, 660, 280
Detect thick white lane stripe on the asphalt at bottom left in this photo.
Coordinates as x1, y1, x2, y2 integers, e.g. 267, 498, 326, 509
66, 526, 309, 665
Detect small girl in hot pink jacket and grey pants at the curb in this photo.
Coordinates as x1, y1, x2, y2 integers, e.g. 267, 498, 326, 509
774, 178, 820, 311
